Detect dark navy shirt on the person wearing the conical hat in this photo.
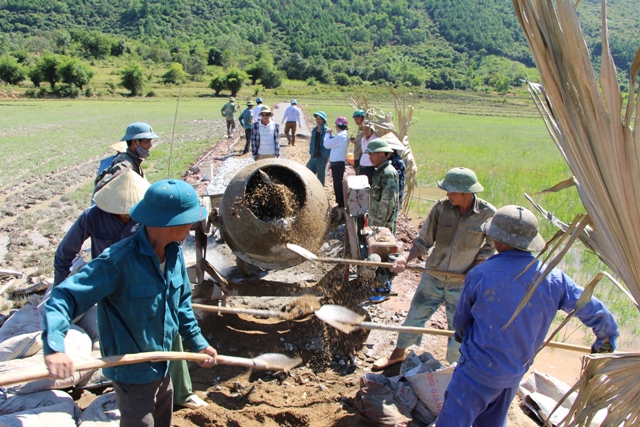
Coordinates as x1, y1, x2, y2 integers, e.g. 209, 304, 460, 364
53, 206, 140, 286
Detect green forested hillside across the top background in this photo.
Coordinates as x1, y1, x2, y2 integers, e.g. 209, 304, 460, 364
0, 0, 640, 96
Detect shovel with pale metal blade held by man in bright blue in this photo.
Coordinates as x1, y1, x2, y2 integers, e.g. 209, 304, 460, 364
315, 304, 591, 353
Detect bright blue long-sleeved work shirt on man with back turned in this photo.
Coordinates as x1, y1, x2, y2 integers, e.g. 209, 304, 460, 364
453, 250, 620, 388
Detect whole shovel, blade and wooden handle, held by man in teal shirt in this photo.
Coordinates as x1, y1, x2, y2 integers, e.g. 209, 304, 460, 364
0, 351, 302, 386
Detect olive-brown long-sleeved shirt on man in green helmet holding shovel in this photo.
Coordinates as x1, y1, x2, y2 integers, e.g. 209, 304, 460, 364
413, 197, 496, 273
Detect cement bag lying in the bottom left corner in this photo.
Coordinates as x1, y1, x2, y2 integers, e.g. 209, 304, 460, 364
0, 391, 82, 427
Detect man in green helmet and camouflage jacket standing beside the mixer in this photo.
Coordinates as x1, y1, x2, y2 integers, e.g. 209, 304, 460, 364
364, 139, 398, 236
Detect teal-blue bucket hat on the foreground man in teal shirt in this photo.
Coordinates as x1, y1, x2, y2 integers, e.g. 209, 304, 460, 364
131, 179, 208, 227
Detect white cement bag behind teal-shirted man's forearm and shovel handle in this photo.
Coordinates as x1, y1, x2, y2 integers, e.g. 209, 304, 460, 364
3, 325, 93, 394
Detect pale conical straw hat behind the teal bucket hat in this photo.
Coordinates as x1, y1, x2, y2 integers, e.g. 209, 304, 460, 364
93, 170, 151, 215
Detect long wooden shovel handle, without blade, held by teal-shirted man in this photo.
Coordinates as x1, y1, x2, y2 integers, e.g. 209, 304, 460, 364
0, 351, 268, 386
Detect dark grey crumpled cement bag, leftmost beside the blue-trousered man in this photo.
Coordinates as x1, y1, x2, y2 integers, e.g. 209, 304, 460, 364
353, 373, 411, 427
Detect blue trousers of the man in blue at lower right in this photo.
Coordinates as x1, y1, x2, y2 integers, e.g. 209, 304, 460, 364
436, 365, 518, 427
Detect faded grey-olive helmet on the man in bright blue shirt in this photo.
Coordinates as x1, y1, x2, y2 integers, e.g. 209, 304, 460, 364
482, 205, 545, 252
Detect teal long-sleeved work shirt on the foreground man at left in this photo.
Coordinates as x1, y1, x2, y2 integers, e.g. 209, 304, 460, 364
42, 227, 209, 384
